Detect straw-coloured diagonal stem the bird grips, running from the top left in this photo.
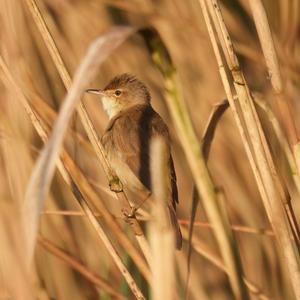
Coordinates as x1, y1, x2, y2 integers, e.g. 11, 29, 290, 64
26, 0, 150, 263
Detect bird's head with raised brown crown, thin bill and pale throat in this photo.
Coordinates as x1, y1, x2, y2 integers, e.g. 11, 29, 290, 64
86, 73, 151, 118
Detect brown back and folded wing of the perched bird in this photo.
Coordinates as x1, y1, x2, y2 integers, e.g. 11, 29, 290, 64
103, 105, 178, 208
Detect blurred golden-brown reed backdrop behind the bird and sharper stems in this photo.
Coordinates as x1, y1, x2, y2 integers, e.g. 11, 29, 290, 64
0, 0, 300, 299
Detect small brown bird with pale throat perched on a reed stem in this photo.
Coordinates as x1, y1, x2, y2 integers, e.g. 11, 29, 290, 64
87, 74, 182, 249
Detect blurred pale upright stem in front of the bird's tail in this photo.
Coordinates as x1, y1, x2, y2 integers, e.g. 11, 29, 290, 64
149, 138, 177, 300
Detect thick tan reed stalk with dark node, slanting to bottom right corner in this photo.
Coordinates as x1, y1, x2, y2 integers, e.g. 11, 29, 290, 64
201, 0, 300, 299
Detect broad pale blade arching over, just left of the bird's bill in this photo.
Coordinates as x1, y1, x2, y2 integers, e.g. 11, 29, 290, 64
23, 27, 133, 268
